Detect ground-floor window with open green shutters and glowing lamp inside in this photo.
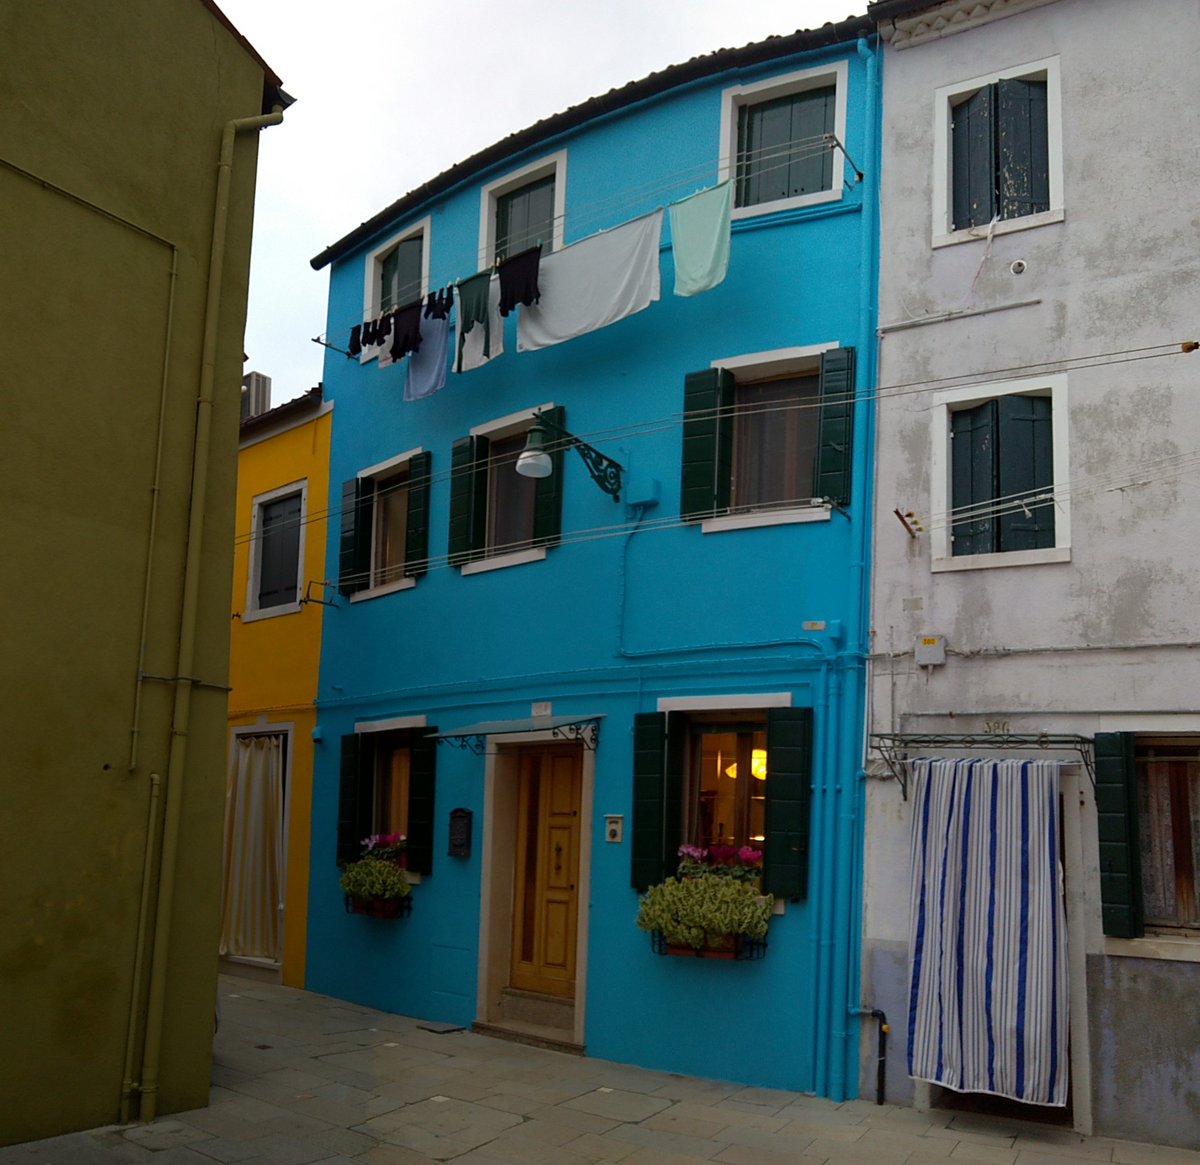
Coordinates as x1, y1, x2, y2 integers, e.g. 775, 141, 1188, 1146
630, 708, 812, 900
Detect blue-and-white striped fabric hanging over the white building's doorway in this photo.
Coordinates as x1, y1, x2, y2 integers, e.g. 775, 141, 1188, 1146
908, 759, 1067, 1105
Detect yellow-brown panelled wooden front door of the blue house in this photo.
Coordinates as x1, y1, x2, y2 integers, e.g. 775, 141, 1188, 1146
511, 745, 583, 999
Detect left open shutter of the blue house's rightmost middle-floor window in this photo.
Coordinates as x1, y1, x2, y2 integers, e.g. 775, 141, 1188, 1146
679, 368, 733, 518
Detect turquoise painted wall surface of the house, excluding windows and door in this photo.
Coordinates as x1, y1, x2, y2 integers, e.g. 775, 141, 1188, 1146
307, 31, 878, 1098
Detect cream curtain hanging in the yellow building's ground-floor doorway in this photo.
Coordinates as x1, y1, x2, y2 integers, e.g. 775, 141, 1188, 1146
221, 735, 283, 961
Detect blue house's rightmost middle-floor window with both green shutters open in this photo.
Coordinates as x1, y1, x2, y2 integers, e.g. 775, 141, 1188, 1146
679, 348, 854, 518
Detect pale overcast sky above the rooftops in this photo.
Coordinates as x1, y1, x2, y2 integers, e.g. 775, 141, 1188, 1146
217, 0, 866, 404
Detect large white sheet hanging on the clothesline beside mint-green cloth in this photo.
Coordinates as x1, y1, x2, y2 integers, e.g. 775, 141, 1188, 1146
517, 209, 662, 352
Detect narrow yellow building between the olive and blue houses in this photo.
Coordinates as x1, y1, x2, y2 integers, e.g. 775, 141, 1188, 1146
221, 373, 334, 987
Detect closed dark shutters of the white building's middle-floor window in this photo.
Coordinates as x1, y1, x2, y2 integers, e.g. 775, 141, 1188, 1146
950, 394, 1055, 556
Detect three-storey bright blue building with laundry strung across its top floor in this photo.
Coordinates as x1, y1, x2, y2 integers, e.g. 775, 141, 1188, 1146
306, 18, 880, 1099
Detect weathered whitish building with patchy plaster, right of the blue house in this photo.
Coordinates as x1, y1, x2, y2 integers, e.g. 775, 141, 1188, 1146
863, 0, 1200, 1147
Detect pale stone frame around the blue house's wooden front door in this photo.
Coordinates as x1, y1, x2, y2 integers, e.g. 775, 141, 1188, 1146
475, 731, 596, 1044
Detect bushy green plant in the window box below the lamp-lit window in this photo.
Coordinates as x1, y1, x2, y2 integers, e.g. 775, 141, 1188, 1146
637, 872, 775, 950
